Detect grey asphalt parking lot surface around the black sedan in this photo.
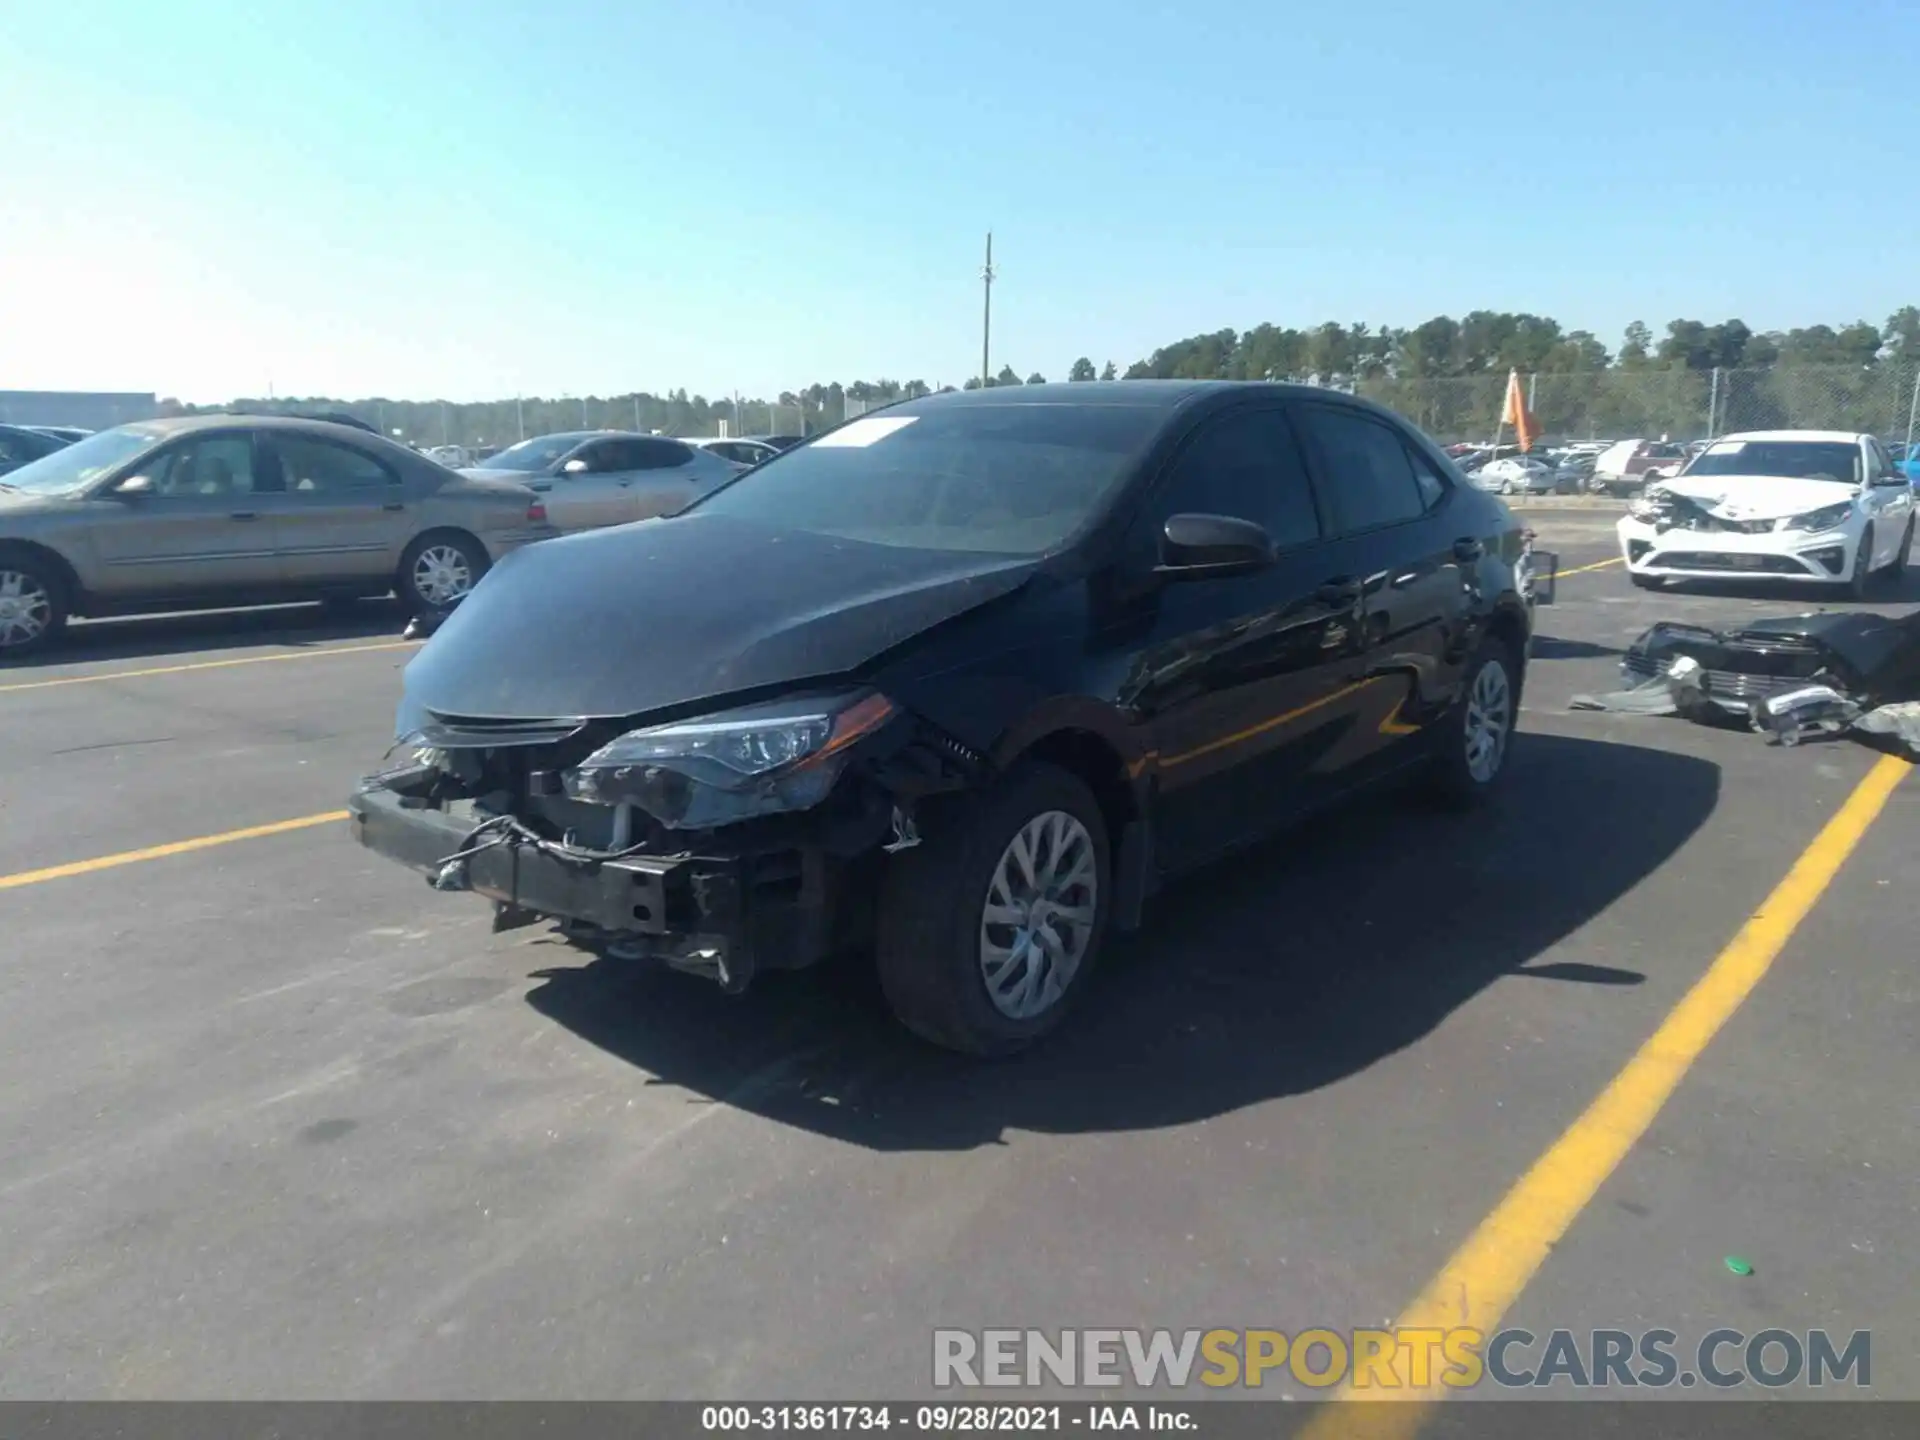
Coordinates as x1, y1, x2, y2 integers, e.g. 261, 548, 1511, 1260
0, 507, 1920, 1400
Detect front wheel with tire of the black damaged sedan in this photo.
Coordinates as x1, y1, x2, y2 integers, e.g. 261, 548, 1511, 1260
877, 762, 1114, 1056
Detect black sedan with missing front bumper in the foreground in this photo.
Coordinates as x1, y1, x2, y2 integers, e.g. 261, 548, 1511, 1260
351, 382, 1532, 1054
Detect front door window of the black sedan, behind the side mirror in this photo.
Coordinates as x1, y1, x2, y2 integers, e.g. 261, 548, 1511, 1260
1139, 409, 1321, 553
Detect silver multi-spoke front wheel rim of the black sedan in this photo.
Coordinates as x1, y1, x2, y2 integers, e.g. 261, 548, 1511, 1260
979, 810, 1100, 1020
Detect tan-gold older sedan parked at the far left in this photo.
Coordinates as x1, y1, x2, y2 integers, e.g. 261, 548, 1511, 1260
0, 415, 559, 659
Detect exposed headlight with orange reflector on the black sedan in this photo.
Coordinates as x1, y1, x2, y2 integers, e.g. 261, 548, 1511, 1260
563, 691, 897, 829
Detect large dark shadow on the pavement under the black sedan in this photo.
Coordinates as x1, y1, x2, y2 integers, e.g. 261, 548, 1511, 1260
528, 735, 1720, 1150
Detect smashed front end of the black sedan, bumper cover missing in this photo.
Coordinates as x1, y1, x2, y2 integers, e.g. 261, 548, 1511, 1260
349, 689, 983, 993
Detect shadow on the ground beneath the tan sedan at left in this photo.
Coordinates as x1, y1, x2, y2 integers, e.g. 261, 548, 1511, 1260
50, 599, 409, 664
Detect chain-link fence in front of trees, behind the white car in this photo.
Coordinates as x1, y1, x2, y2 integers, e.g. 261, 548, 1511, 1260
1357, 361, 1920, 444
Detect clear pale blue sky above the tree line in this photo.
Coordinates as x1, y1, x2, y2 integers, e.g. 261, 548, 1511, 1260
0, 0, 1920, 399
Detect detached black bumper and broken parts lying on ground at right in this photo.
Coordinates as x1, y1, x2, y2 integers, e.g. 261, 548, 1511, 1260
1571, 611, 1920, 758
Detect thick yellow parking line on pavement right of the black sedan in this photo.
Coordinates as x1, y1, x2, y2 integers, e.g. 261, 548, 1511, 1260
1300, 755, 1912, 1440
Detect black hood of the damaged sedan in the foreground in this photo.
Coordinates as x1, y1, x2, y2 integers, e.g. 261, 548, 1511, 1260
405, 511, 1037, 720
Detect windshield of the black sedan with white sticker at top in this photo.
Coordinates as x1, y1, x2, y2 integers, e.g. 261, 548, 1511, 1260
699, 405, 1164, 555
